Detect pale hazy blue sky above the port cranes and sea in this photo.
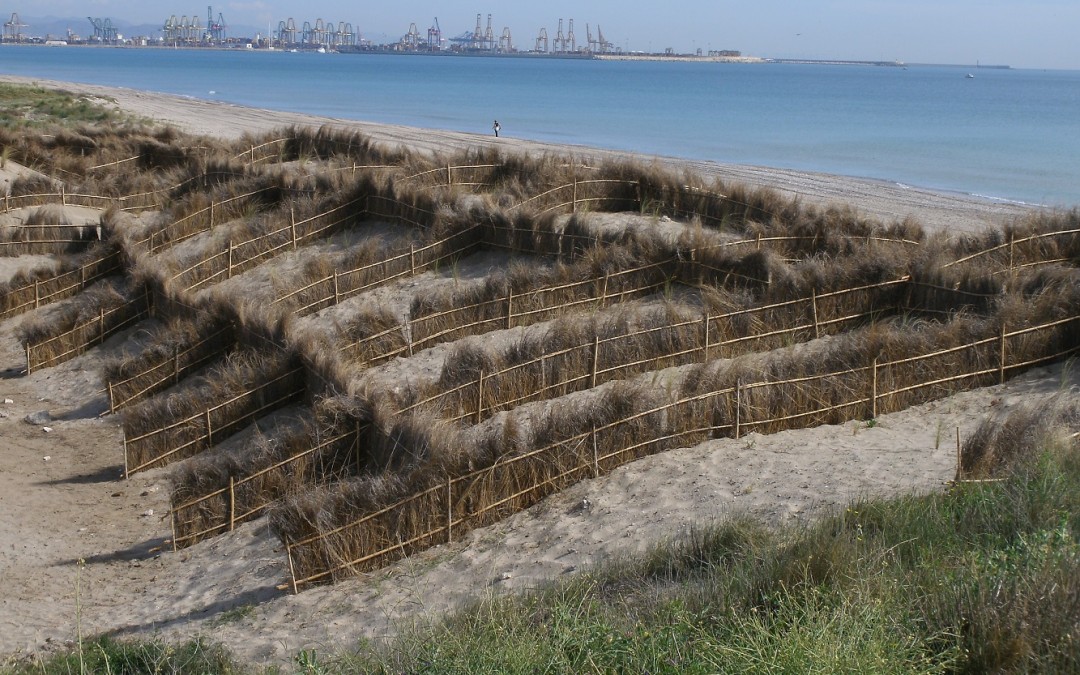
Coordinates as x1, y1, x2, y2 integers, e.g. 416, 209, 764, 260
16, 0, 1080, 69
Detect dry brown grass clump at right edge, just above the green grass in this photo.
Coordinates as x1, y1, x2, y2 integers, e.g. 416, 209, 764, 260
957, 387, 1080, 480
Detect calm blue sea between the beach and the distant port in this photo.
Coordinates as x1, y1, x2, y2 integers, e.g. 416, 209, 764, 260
0, 44, 1080, 207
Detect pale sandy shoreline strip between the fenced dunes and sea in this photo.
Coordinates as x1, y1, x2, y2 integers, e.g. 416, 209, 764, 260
0, 70, 1041, 232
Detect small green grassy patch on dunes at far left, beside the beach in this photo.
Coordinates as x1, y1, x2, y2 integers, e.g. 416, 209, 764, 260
0, 83, 122, 129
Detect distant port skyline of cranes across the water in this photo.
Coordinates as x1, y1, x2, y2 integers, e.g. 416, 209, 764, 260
3, 5, 739, 56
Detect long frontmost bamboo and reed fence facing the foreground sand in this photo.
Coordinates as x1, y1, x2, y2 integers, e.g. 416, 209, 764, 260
285, 316, 1080, 592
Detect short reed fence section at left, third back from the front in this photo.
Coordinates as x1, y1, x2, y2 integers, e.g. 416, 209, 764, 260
122, 349, 306, 472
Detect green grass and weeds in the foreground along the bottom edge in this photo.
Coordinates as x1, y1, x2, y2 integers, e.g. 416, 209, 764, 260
4, 440, 1080, 673
